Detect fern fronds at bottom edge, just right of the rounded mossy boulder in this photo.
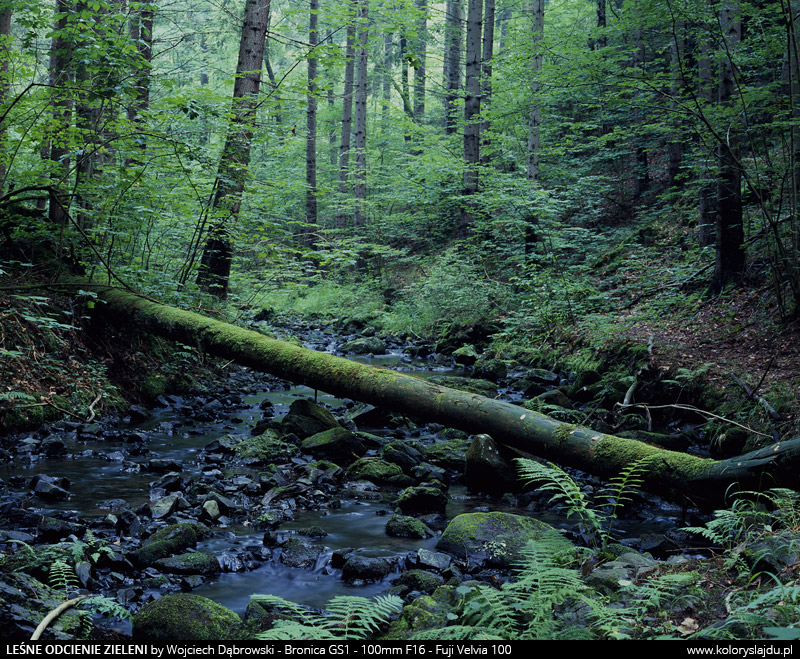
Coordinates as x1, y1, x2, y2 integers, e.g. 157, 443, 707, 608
252, 595, 403, 640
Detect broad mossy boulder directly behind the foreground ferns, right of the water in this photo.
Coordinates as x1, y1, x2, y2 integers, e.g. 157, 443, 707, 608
436, 512, 566, 568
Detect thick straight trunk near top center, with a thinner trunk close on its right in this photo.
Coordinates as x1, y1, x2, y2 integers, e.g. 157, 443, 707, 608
464, 0, 483, 195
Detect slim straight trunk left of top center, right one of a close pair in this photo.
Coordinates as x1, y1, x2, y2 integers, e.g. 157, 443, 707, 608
353, 0, 369, 229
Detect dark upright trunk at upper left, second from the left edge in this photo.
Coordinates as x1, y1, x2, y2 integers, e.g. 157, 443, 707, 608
47, 0, 73, 226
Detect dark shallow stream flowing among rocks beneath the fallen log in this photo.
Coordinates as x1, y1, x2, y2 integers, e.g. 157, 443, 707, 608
0, 320, 683, 634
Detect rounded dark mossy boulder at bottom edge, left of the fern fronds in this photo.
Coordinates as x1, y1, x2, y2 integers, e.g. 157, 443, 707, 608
132, 593, 242, 641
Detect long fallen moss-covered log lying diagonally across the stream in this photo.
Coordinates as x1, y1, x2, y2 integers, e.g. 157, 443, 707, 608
84, 284, 800, 506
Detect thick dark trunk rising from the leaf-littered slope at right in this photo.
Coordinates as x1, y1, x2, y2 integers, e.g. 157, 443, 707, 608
711, 1, 745, 291
